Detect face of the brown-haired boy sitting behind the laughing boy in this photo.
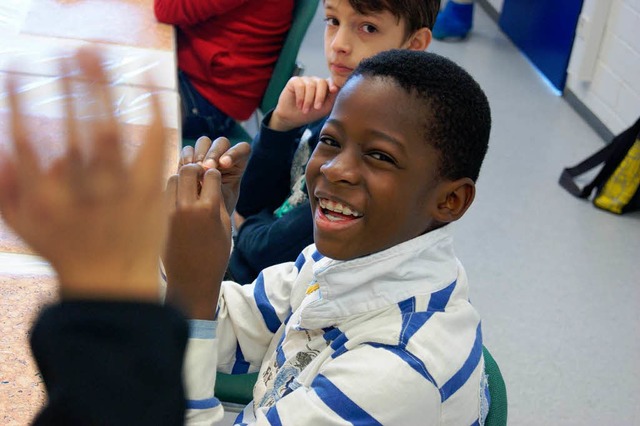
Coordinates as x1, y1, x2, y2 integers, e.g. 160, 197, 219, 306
324, 0, 428, 87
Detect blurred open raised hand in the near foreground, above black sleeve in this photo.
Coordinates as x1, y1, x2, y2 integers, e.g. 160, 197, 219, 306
0, 49, 166, 302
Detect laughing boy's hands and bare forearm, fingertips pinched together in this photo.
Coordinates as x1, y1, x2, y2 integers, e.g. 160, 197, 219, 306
163, 138, 251, 319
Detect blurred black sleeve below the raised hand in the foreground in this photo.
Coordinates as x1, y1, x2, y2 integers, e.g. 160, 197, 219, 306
31, 301, 188, 426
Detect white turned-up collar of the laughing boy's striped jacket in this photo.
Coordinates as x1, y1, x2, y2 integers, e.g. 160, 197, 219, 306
295, 224, 459, 328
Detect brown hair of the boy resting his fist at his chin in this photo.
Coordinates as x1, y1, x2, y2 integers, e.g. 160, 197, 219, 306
349, 0, 440, 36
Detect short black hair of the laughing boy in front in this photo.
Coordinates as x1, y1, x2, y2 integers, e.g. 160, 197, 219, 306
349, 49, 491, 181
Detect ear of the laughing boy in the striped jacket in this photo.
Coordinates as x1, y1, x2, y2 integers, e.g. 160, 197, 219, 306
433, 178, 476, 223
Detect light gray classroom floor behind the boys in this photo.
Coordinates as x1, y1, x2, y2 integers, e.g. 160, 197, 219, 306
226, 4, 640, 425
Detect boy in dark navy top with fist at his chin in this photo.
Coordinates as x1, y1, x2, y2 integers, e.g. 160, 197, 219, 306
187, 0, 440, 283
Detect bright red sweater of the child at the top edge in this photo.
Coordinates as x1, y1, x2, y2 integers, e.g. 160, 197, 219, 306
154, 0, 294, 120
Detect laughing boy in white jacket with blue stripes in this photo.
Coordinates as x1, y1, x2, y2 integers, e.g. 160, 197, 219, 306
168, 50, 491, 425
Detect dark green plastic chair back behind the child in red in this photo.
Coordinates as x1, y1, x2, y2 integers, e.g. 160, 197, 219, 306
182, 0, 319, 146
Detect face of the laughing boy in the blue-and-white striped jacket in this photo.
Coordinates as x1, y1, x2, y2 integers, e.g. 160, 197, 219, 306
306, 76, 448, 260
